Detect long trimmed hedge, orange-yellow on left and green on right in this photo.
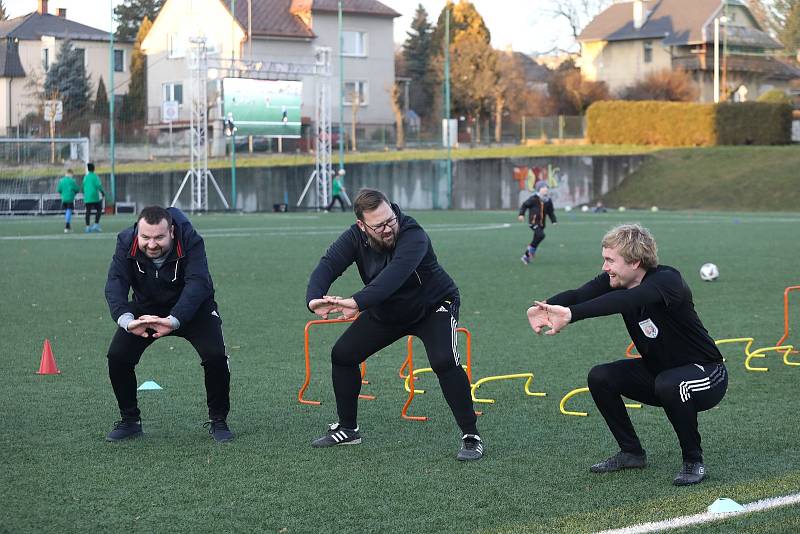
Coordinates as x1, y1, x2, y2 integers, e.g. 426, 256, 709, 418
586, 100, 792, 146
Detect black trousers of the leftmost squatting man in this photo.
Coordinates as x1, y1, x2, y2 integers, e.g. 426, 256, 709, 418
108, 306, 231, 420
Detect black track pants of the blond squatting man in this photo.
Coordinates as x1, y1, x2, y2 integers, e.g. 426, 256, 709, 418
589, 358, 728, 462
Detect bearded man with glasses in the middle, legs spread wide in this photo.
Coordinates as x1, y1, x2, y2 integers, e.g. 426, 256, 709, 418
306, 189, 484, 461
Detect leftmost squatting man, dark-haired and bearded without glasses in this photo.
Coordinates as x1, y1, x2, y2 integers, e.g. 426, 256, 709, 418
106, 206, 233, 443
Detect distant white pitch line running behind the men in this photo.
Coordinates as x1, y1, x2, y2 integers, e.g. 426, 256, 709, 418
0, 223, 511, 241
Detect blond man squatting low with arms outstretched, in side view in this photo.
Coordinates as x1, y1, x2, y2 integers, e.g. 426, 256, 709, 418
528, 224, 728, 486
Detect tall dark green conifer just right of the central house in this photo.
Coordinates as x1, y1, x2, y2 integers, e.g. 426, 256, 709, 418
403, 4, 433, 117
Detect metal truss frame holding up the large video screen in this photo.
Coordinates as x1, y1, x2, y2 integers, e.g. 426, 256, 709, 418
172, 37, 333, 211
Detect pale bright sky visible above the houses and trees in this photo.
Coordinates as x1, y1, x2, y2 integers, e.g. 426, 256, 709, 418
4, 0, 572, 53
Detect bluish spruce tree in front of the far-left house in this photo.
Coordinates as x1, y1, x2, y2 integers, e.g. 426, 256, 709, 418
44, 39, 91, 114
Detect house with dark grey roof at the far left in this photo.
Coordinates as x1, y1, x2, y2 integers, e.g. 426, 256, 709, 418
0, 0, 133, 136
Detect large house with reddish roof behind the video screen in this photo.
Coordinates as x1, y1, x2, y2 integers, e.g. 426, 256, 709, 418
142, 0, 400, 146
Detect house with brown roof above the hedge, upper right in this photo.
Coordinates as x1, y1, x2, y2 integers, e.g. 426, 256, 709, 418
578, 0, 800, 102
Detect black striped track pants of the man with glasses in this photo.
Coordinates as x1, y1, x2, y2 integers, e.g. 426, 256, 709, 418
331, 299, 477, 434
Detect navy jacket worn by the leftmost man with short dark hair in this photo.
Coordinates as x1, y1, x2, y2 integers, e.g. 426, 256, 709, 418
106, 208, 216, 326
